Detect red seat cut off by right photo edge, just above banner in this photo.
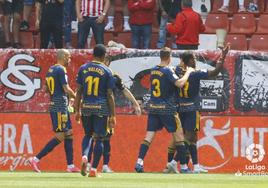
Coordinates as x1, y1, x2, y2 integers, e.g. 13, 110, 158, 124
249, 35, 268, 52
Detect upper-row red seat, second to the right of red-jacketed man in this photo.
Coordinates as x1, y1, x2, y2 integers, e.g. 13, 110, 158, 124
230, 13, 256, 36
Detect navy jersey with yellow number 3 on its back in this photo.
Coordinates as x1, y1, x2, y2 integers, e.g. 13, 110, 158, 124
149, 66, 178, 114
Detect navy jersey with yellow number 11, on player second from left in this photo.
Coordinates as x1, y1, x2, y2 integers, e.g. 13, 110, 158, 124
77, 62, 114, 115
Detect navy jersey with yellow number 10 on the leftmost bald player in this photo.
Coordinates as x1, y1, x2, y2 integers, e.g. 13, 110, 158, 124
46, 64, 68, 111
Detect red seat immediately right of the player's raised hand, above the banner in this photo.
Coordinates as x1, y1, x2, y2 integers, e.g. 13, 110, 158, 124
225, 34, 248, 51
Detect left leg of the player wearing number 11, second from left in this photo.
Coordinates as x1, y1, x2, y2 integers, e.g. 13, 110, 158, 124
81, 115, 93, 176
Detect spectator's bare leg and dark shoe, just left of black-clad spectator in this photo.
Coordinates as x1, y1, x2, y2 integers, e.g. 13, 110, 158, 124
20, 0, 35, 31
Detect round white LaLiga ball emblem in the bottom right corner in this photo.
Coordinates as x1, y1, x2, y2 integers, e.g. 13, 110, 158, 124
246, 144, 265, 163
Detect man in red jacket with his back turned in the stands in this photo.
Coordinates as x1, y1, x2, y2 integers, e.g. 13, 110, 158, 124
166, 0, 205, 50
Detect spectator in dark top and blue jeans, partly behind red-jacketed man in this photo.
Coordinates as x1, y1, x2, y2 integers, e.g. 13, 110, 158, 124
157, 0, 181, 48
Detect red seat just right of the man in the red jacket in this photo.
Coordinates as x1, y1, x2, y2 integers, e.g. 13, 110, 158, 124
205, 14, 229, 33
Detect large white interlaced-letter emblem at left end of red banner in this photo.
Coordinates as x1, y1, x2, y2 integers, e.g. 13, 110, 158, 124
0, 54, 41, 102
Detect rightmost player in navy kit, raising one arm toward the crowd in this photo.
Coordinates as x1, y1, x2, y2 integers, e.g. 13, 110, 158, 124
166, 45, 230, 173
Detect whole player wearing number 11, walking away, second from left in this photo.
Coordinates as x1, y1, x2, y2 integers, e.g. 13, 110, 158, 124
74, 44, 116, 177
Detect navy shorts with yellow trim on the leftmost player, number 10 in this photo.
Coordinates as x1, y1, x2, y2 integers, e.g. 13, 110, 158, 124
50, 112, 72, 132
